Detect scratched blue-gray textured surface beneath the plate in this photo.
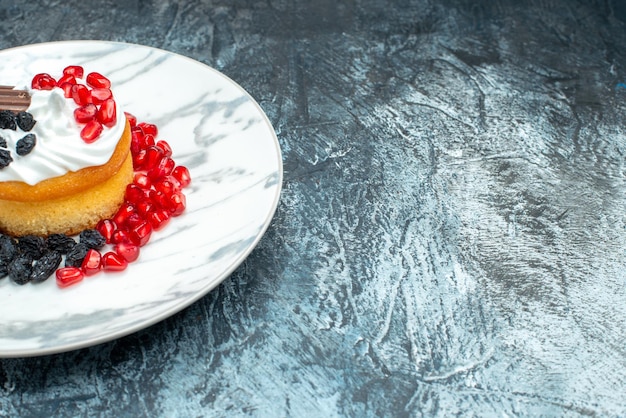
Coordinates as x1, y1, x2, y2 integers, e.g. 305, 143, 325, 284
0, 0, 626, 417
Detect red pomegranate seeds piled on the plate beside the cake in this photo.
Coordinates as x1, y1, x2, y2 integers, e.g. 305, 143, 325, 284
56, 113, 191, 287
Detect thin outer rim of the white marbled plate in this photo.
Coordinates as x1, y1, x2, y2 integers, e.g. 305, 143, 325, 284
0, 39, 284, 359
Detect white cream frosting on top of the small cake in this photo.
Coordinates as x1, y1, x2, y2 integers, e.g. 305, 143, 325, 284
0, 87, 126, 186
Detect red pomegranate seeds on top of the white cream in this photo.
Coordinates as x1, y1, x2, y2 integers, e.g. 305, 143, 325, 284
31, 65, 117, 143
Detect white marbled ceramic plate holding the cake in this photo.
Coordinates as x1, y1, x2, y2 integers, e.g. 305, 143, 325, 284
0, 41, 282, 357
